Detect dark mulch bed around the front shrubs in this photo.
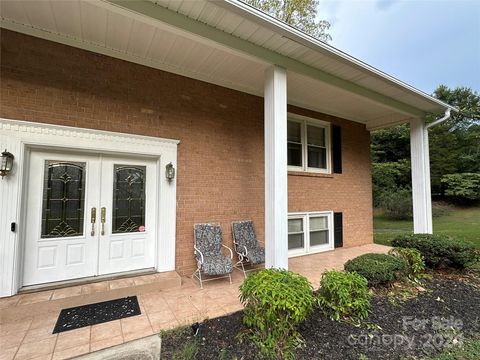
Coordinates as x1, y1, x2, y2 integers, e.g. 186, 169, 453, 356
162, 276, 480, 360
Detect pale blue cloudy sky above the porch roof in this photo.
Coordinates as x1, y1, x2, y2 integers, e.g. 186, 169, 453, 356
318, 0, 480, 94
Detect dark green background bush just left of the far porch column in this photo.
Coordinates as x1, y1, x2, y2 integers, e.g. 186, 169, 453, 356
379, 188, 413, 220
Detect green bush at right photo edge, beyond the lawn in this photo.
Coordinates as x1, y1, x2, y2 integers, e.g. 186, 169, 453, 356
440, 173, 480, 201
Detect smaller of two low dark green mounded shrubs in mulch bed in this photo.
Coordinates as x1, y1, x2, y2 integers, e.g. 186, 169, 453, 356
345, 253, 407, 286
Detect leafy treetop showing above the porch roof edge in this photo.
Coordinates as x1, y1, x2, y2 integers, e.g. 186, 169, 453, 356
242, 0, 332, 43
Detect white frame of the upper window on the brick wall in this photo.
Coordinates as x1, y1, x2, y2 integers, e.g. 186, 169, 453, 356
287, 113, 331, 174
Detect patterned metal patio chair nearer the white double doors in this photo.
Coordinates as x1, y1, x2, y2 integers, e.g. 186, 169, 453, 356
192, 224, 233, 289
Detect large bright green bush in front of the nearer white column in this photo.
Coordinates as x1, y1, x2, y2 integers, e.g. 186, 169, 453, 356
240, 269, 316, 359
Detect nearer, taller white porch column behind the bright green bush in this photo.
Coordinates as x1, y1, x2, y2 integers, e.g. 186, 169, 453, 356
264, 66, 288, 269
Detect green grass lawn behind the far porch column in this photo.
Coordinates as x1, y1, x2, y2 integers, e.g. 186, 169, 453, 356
373, 207, 480, 248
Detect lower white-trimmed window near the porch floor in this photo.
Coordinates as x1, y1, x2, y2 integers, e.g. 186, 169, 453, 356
288, 211, 333, 256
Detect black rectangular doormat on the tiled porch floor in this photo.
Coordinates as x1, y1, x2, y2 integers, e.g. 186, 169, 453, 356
53, 296, 141, 334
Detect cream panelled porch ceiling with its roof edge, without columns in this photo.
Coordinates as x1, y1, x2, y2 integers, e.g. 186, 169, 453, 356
1, 0, 448, 128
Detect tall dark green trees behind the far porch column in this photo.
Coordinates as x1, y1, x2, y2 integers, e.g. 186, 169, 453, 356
371, 85, 480, 204
